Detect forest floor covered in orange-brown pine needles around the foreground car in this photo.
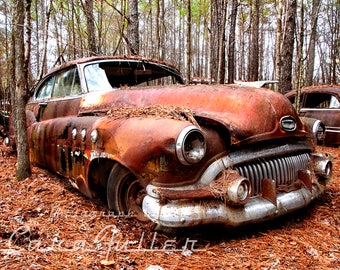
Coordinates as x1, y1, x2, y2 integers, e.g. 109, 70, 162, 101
0, 146, 340, 270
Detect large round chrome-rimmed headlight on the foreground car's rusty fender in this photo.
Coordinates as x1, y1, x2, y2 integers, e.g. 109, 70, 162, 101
176, 126, 206, 165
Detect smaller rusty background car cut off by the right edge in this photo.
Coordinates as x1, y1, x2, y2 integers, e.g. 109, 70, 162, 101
286, 85, 340, 147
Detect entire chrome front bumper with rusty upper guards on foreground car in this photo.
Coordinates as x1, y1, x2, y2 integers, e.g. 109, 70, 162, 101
142, 150, 332, 227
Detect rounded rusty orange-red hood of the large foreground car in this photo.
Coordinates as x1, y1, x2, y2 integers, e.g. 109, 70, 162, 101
80, 85, 306, 143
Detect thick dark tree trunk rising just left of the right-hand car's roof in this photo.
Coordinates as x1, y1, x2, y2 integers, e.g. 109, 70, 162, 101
279, 0, 296, 94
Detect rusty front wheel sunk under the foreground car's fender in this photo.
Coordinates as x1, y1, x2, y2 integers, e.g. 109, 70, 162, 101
106, 164, 147, 221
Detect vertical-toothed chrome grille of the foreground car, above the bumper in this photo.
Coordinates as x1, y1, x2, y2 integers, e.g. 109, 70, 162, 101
235, 153, 310, 196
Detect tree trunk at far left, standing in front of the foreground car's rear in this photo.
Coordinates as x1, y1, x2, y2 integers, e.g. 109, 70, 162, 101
13, 0, 31, 180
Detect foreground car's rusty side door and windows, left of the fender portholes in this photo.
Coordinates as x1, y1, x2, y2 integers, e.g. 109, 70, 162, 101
26, 67, 82, 176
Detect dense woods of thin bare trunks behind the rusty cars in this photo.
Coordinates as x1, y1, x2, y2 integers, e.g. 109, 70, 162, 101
0, 0, 340, 98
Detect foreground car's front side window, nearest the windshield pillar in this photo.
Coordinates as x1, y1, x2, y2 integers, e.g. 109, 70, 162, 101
53, 68, 81, 97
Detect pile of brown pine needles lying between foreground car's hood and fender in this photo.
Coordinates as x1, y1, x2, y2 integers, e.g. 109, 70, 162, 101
107, 104, 198, 126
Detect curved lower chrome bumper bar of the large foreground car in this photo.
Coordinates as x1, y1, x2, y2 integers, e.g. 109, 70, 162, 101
143, 185, 324, 227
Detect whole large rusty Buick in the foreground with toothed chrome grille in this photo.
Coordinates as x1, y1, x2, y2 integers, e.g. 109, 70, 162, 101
5, 57, 332, 227
